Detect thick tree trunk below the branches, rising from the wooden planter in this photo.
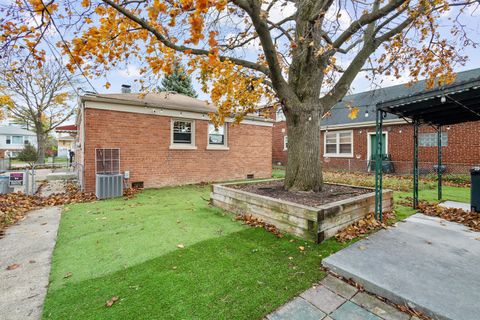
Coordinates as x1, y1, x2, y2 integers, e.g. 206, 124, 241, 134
284, 106, 323, 192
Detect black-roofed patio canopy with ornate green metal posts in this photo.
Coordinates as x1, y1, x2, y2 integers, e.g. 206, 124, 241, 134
375, 77, 480, 220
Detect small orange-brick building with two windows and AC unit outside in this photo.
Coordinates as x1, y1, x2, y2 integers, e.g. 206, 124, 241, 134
76, 93, 273, 192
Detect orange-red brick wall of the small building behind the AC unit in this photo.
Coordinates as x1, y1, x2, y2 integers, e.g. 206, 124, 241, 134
80, 108, 272, 192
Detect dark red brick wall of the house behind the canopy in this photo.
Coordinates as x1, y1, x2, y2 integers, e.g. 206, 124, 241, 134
273, 121, 480, 171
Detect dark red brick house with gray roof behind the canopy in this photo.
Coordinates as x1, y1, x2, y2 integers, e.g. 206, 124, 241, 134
272, 68, 480, 173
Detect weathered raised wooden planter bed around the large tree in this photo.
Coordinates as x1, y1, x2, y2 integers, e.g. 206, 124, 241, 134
210, 181, 393, 243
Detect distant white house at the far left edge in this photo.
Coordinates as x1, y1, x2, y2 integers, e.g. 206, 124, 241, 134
0, 125, 37, 158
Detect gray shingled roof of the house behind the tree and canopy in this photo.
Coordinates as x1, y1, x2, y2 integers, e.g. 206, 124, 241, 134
322, 68, 480, 126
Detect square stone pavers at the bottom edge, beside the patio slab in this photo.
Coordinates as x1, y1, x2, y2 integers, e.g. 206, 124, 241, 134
267, 275, 418, 320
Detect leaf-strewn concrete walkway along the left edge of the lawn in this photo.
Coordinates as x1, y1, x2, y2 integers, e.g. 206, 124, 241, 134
0, 207, 61, 320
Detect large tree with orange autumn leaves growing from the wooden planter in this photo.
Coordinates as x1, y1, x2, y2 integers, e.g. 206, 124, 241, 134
0, 0, 478, 190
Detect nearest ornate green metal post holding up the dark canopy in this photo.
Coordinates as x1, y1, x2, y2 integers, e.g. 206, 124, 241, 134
372, 109, 384, 221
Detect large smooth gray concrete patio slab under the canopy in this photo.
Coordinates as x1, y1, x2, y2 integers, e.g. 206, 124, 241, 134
323, 214, 480, 320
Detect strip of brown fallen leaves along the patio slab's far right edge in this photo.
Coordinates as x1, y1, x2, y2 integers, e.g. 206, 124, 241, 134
418, 201, 480, 231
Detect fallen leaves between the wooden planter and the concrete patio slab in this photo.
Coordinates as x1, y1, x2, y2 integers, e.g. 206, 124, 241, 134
335, 211, 395, 242
